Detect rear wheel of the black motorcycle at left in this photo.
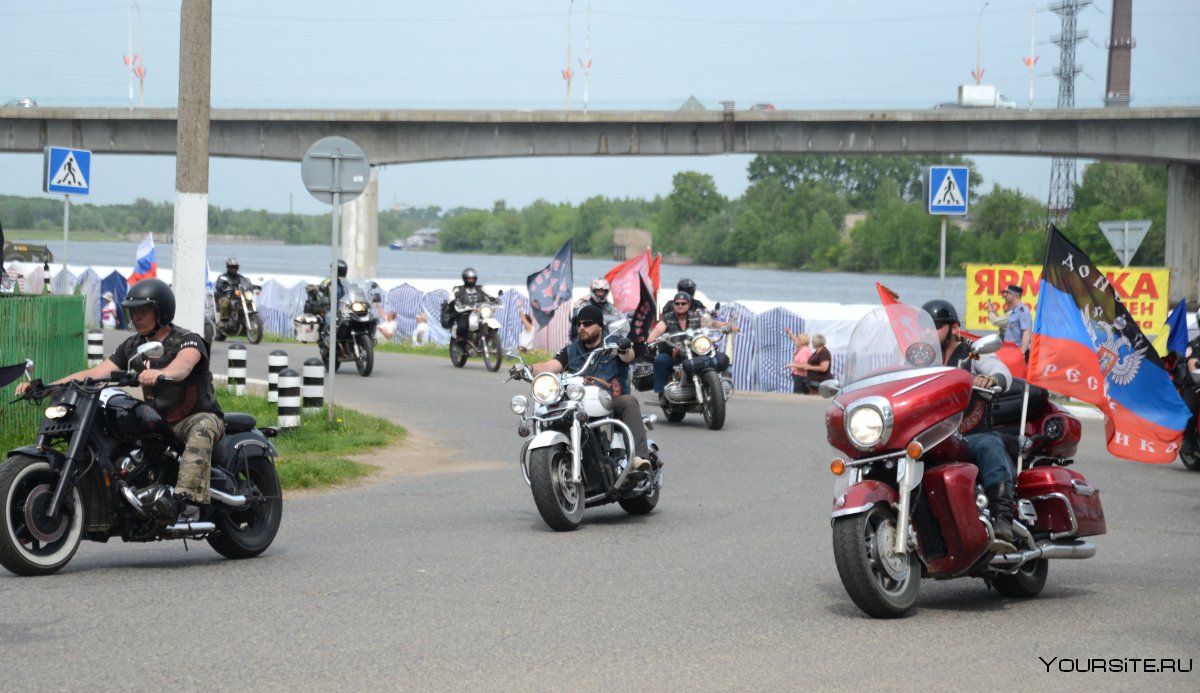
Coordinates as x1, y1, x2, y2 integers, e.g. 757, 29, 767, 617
209, 457, 283, 559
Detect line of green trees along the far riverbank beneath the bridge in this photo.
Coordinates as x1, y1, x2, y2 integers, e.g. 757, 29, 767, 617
0, 156, 1166, 275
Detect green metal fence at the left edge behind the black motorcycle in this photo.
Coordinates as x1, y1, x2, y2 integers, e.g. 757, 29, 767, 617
0, 294, 88, 430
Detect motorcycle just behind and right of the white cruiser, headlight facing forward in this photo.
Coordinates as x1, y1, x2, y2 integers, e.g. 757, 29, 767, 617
635, 303, 733, 430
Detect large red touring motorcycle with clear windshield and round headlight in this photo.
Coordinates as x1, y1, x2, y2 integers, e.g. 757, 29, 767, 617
821, 305, 1105, 619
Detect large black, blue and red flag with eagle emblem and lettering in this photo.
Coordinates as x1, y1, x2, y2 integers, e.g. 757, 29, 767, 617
1028, 224, 1189, 464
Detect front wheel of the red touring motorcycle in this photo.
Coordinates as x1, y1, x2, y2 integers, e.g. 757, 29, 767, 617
833, 505, 920, 619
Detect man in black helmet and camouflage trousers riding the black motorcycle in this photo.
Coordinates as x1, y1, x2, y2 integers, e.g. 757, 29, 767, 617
17, 279, 224, 519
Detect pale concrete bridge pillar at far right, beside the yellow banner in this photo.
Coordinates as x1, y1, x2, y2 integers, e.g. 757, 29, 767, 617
1166, 163, 1200, 307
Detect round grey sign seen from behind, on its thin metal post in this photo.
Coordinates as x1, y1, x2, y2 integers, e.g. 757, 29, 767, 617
300, 131, 371, 423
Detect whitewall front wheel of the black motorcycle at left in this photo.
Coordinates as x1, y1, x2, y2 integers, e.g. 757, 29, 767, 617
0, 454, 83, 576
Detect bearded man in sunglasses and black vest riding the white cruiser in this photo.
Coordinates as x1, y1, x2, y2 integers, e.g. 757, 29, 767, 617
530, 306, 662, 471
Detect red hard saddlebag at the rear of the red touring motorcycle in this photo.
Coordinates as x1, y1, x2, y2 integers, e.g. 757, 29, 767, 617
1016, 466, 1108, 537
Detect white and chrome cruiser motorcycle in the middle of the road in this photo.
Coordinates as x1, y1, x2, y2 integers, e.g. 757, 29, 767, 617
505, 318, 662, 531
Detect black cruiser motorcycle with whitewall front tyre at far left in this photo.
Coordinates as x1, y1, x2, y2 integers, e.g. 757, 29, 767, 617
0, 342, 283, 576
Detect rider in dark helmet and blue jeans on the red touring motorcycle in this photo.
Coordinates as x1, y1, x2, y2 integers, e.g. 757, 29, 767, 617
922, 299, 1014, 542
